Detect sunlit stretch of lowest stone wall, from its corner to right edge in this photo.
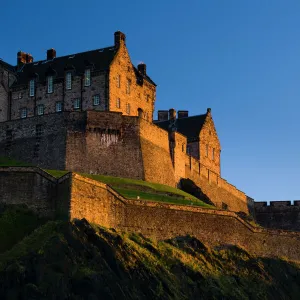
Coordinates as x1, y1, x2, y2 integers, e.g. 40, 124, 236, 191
70, 175, 300, 261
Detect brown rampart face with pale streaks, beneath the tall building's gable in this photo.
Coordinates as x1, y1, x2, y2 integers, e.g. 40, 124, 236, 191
66, 111, 144, 179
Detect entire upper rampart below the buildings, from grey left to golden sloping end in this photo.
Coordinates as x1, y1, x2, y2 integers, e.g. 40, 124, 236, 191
0, 111, 253, 213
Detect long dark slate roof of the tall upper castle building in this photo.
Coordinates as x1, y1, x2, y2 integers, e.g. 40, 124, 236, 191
10, 46, 155, 86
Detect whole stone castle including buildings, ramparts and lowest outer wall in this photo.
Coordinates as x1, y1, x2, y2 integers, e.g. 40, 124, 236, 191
0, 31, 300, 260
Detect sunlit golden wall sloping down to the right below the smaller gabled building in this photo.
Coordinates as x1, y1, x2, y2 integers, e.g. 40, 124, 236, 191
186, 156, 253, 214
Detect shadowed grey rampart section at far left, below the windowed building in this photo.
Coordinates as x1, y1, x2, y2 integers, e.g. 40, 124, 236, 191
0, 113, 67, 169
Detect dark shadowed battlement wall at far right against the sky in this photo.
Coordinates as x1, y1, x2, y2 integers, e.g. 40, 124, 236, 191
254, 200, 300, 231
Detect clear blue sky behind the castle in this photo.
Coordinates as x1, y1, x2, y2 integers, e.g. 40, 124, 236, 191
0, 0, 300, 201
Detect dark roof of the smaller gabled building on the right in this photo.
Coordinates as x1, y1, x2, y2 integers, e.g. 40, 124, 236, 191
154, 114, 207, 140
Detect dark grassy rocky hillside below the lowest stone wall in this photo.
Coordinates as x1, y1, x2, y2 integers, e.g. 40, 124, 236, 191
0, 208, 300, 300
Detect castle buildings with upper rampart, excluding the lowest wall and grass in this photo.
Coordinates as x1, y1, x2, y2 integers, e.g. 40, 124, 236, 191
0, 31, 253, 213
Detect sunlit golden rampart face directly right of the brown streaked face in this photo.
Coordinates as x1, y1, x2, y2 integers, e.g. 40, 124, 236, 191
139, 119, 176, 186
